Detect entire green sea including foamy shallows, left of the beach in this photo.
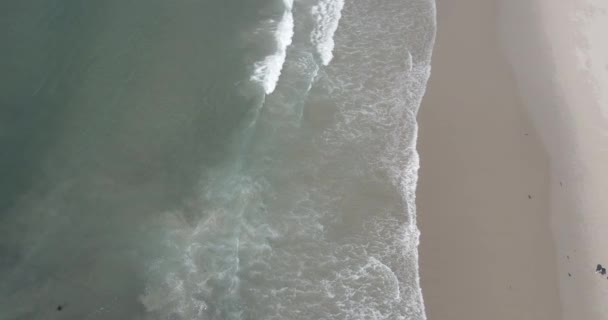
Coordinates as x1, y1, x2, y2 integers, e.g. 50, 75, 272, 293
0, 0, 435, 320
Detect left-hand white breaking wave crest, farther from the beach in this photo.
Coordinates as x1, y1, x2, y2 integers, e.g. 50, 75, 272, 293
251, 0, 294, 94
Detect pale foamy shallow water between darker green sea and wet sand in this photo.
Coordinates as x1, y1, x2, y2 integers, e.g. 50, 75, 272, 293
177, 0, 435, 320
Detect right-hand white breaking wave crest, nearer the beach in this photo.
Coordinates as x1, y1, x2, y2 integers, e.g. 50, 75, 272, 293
310, 0, 344, 65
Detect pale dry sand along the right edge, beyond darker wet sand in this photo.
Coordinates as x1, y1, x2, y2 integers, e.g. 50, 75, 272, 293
500, 0, 608, 320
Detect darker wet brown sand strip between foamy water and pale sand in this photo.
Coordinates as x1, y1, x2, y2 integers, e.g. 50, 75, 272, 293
417, 0, 567, 320
